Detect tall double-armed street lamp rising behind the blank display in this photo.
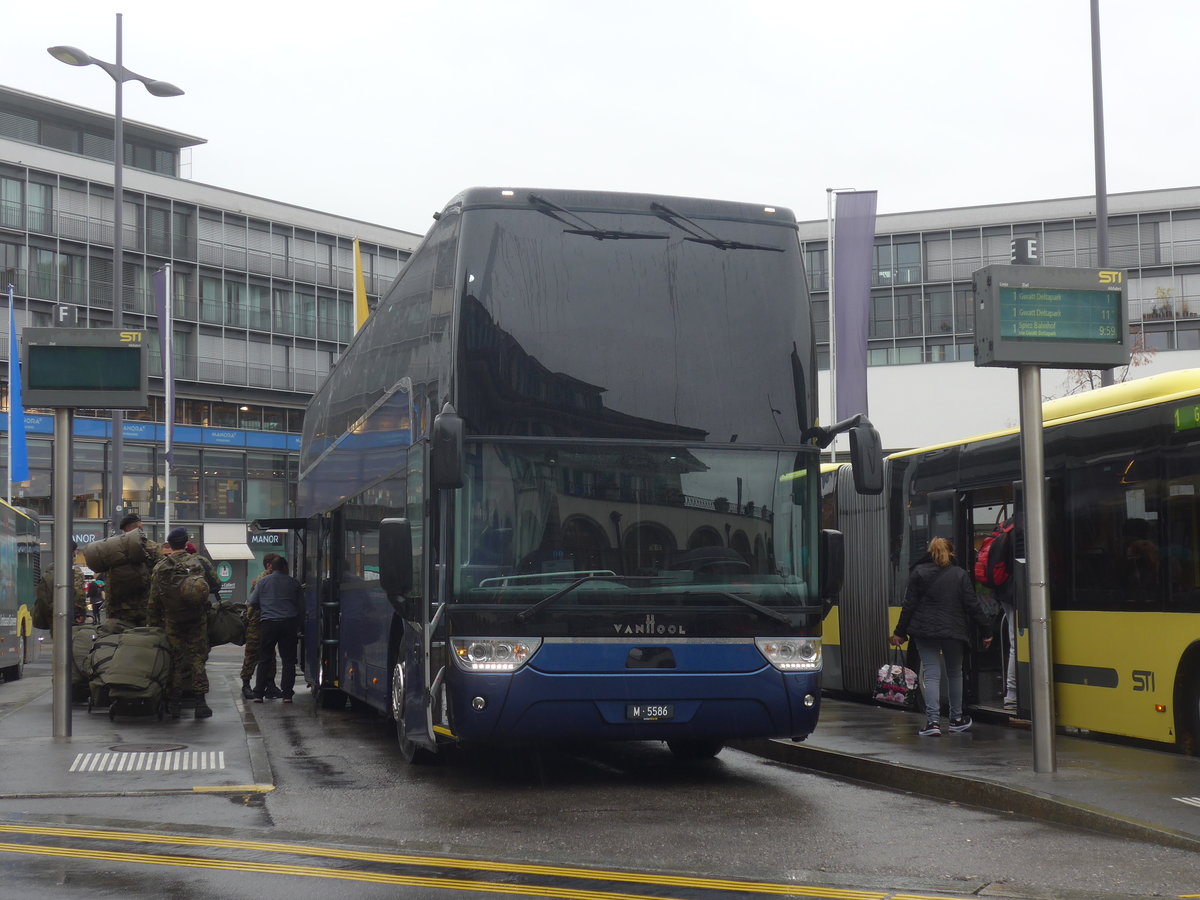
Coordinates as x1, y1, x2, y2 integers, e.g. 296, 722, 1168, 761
47, 13, 184, 534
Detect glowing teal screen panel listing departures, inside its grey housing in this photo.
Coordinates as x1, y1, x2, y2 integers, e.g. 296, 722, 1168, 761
1000, 287, 1123, 343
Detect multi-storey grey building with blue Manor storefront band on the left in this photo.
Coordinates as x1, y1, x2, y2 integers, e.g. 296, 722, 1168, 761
0, 88, 420, 595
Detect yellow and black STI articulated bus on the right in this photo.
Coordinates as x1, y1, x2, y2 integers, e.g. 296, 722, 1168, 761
822, 370, 1200, 754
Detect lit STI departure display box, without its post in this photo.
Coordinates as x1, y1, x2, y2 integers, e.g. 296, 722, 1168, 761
973, 265, 1129, 368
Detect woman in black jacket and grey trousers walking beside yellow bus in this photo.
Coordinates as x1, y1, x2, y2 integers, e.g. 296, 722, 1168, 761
889, 538, 991, 737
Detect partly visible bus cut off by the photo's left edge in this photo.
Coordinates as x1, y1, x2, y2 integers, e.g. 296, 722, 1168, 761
0, 500, 40, 682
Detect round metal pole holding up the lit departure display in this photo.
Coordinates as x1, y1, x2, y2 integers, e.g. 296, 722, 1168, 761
1018, 364, 1056, 773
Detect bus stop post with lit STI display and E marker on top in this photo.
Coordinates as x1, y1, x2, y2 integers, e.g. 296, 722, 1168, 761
974, 262, 1129, 773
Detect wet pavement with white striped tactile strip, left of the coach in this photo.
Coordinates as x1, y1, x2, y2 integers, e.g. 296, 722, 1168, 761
0, 647, 274, 800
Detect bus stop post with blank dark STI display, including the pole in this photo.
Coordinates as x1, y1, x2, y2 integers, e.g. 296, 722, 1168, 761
22, 328, 149, 738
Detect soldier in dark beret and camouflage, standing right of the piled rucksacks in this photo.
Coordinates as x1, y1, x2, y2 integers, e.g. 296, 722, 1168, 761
146, 528, 221, 719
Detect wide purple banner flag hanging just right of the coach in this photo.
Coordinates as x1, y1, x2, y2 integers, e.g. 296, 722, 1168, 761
833, 191, 877, 421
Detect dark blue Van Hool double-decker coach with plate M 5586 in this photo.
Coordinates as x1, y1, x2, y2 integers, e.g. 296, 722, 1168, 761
280, 188, 881, 761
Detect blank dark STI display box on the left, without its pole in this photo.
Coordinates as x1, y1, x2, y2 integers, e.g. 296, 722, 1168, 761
23, 328, 148, 409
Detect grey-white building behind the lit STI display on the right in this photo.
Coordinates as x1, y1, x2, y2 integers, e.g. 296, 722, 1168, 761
800, 187, 1200, 449
